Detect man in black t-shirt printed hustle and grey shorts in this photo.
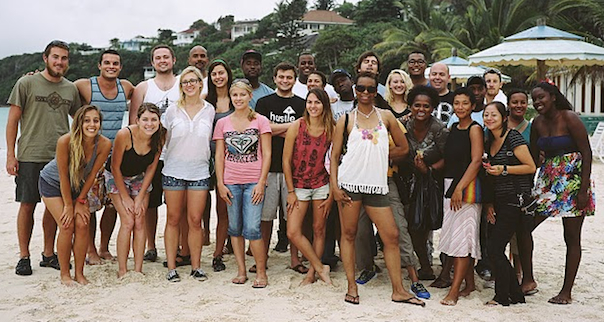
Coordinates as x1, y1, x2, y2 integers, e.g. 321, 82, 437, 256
256, 63, 308, 273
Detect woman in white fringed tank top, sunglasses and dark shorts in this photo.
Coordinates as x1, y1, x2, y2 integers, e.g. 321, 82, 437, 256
331, 72, 425, 306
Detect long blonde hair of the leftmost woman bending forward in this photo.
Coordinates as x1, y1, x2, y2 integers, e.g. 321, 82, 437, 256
69, 105, 103, 189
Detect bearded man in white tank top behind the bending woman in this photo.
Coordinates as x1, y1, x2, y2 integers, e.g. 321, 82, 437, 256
130, 45, 179, 265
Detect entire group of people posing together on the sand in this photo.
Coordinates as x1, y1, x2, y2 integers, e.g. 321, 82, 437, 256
6, 41, 595, 306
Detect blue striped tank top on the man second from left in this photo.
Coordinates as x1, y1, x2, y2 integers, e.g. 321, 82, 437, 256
90, 77, 128, 142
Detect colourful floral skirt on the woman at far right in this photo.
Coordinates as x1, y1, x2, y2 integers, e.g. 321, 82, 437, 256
533, 152, 596, 218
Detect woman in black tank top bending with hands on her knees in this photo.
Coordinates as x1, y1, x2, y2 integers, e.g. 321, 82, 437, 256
105, 103, 166, 277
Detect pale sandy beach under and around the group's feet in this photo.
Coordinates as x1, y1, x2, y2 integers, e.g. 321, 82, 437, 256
0, 160, 604, 322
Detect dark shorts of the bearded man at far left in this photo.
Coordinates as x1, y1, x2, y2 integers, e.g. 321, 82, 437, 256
15, 162, 48, 203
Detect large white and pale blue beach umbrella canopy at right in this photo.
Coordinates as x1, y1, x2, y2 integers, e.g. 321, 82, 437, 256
468, 25, 604, 79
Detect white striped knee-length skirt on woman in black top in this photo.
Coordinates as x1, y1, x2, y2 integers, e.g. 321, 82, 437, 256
439, 179, 482, 259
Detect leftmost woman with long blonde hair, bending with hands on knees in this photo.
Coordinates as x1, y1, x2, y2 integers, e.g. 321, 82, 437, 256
38, 105, 111, 286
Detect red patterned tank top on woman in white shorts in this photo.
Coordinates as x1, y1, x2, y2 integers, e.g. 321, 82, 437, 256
292, 118, 331, 189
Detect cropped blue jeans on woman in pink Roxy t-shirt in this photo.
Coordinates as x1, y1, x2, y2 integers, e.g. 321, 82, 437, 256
226, 183, 264, 240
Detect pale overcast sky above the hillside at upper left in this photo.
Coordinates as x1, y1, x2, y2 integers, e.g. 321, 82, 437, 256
0, 0, 358, 59
